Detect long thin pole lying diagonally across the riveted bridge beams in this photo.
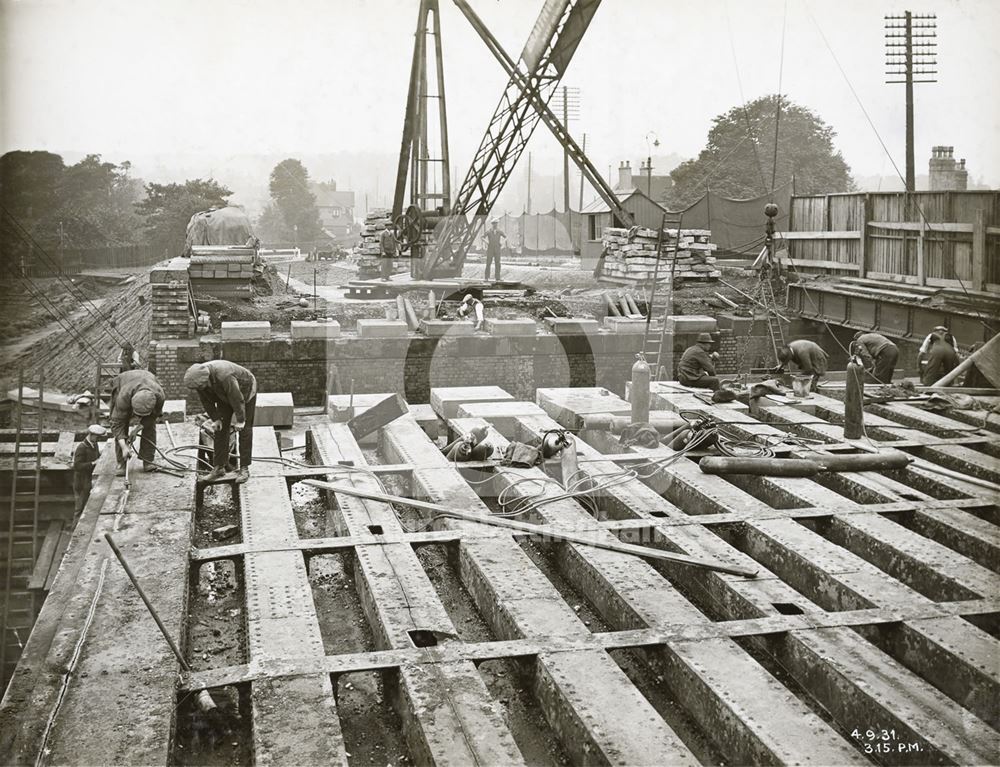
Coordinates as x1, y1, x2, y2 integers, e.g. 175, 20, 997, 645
302, 479, 757, 578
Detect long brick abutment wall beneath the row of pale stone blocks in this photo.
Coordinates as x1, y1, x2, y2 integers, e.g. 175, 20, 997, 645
150, 333, 724, 411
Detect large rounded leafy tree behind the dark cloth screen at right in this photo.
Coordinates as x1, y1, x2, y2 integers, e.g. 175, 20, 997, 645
670, 96, 854, 208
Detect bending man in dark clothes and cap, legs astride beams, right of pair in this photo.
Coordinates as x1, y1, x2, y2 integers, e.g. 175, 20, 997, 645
184, 360, 257, 484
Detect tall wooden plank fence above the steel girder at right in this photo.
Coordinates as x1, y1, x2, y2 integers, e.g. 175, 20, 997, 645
782, 191, 1000, 293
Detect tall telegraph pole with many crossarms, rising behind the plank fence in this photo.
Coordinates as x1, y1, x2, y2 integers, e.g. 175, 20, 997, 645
885, 11, 937, 192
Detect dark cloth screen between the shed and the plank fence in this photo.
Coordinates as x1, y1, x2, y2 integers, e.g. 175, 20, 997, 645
671, 181, 793, 255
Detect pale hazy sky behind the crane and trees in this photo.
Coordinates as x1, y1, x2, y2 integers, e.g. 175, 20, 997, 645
0, 0, 1000, 213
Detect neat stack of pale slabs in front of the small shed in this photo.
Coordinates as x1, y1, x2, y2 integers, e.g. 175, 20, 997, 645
603, 227, 722, 282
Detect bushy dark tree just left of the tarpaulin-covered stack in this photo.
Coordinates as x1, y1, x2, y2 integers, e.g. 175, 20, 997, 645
135, 178, 233, 255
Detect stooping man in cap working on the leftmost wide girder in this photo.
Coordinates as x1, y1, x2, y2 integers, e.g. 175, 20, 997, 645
109, 369, 166, 477
